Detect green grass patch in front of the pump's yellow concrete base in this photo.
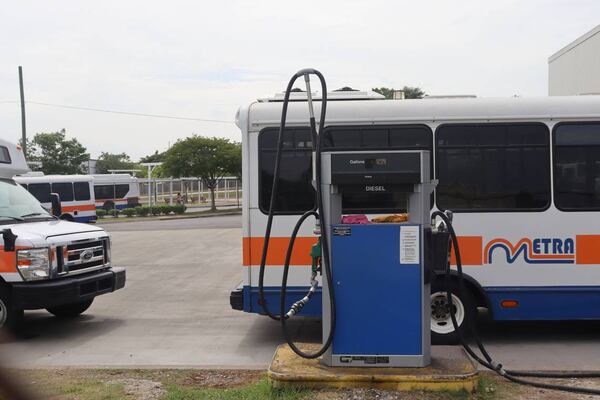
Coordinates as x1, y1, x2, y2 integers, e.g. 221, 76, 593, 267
165, 378, 311, 400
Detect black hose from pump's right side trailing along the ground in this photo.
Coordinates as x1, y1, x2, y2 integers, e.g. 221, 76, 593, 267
431, 211, 600, 395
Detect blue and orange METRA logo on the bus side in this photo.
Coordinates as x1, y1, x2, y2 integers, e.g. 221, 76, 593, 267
483, 238, 575, 264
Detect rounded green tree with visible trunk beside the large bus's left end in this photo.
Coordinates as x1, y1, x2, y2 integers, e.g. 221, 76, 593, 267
161, 135, 242, 211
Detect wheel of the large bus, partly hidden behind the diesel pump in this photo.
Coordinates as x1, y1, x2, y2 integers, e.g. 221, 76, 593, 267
431, 277, 477, 345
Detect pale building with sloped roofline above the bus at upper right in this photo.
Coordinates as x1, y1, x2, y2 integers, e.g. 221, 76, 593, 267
548, 25, 600, 96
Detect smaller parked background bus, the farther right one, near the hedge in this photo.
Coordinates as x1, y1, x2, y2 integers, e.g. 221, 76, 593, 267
92, 174, 140, 211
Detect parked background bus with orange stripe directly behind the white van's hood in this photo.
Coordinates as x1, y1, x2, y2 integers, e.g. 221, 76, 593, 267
14, 172, 97, 222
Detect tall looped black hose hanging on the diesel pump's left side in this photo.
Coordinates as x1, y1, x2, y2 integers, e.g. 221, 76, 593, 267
258, 68, 336, 358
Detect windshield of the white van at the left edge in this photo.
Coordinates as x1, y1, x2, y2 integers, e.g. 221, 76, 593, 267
0, 179, 53, 224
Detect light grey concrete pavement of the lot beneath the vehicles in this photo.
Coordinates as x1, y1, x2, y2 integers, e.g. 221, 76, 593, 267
0, 216, 600, 370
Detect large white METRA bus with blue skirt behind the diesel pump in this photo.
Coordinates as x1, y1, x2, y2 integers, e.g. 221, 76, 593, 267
231, 92, 600, 343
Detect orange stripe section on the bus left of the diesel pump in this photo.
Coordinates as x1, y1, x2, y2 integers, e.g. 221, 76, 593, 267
242, 237, 317, 266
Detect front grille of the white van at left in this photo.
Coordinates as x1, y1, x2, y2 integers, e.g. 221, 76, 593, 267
57, 239, 109, 274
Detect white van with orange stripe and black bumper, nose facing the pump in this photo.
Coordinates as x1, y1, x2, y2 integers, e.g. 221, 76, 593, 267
0, 139, 125, 328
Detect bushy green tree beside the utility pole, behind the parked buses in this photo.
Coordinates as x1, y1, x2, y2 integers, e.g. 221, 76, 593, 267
27, 129, 90, 175
